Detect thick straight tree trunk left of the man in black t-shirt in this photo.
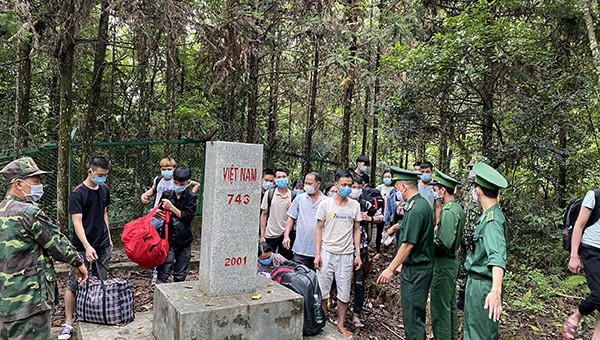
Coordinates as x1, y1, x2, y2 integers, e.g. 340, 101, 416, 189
56, 0, 76, 233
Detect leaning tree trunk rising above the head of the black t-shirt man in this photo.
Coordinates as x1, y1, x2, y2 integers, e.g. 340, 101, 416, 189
79, 0, 110, 177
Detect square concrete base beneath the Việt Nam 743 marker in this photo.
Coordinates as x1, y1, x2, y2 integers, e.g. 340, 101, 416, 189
153, 276, 304, 340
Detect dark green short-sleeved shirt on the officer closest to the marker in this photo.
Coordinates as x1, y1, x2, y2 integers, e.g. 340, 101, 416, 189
400, 194, 433, 265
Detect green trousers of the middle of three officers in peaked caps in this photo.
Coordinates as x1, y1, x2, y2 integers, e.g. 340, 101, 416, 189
431, 256, 460, 340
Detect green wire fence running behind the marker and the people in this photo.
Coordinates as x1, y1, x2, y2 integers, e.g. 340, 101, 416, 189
0, 139, 339, 229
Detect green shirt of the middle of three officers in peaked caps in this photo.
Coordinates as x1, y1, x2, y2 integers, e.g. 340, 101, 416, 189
433, 199, 465, 258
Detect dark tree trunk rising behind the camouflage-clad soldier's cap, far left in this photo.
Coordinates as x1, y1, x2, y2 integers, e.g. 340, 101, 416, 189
14, 31, 32, 151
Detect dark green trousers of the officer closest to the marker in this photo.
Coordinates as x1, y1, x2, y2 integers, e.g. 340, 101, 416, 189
400, 263, 433, 340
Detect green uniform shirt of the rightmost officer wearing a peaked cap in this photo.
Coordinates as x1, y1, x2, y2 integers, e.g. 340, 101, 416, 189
465, 204, 507, 279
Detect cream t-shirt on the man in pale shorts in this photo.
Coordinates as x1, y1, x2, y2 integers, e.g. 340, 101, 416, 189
317, 198, 362, 255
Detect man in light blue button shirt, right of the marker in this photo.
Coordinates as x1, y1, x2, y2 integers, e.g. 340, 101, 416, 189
283, 171, 325, 270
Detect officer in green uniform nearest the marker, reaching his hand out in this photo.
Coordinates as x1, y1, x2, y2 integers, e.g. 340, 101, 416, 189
377, 170, 433, 340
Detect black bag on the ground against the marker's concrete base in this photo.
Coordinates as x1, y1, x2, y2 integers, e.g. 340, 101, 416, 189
280, 261, 326, 335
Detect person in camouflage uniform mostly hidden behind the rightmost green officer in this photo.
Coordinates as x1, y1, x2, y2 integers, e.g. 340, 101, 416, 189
456, 155, 490, 309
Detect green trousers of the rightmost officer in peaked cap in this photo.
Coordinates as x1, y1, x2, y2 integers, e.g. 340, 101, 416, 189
465, 275, 498, 340
